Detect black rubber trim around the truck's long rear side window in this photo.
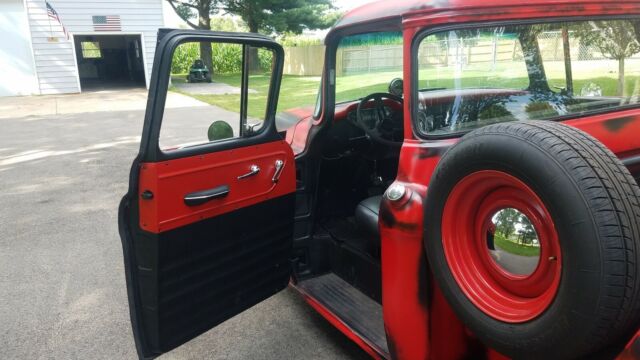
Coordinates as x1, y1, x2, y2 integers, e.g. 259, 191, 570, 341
409, 15, 640, 140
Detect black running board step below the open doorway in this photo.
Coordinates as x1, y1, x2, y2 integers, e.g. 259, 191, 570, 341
295, 273, 389, 358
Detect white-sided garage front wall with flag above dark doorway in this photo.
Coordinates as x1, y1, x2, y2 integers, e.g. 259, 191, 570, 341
26, 0, 164, 94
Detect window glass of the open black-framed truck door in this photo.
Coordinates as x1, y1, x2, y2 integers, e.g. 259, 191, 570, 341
160, 42, 274, 151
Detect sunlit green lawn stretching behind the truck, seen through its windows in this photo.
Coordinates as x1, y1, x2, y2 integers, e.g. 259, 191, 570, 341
171, 61, 640, 119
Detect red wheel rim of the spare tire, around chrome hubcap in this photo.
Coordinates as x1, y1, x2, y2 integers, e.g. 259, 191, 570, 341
442, 170, 562, 323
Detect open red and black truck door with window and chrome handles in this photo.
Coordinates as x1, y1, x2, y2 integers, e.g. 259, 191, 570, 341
119, 30, 295, 358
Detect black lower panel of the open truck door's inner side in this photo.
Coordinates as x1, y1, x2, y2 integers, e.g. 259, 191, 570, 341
135, 194, 294, 356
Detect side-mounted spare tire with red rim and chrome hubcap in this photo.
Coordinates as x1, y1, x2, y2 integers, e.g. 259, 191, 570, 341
424, 121, 640, 359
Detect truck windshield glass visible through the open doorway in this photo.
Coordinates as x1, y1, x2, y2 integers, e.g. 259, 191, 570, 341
336, 32, 402, 103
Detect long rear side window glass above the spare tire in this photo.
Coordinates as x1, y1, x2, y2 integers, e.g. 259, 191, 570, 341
416, 20, 640, 135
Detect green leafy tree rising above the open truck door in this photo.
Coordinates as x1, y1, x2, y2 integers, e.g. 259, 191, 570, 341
167, 0, 338, 71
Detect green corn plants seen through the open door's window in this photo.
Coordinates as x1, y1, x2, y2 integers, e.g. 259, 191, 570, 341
171, 42, 273, 74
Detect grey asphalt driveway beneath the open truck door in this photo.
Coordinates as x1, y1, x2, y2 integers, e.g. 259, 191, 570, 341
0, 90, 366, 359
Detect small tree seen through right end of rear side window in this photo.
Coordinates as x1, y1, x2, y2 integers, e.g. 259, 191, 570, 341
578, 20, 640, 96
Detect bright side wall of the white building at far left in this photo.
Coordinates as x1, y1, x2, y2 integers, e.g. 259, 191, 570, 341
0, 0, 39, 96
